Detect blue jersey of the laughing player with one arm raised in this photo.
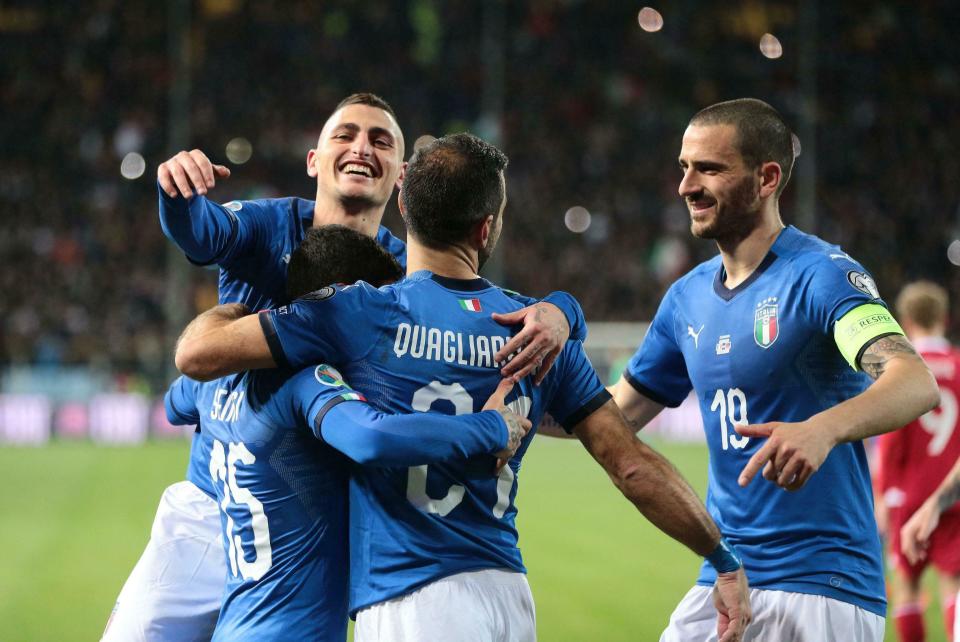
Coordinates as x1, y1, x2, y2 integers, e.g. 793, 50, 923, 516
159, 190, 407, 497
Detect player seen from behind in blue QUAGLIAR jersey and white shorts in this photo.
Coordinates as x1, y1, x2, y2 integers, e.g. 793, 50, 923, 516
177, 134, 750, 642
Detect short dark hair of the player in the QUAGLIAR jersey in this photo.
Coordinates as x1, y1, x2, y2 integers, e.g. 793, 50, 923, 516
400, 133, 509, 248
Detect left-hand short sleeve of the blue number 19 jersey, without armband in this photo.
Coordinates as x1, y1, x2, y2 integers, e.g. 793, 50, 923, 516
623, 288, 693, 408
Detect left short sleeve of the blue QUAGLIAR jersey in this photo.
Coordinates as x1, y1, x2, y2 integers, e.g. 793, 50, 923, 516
260, 282, 385, 369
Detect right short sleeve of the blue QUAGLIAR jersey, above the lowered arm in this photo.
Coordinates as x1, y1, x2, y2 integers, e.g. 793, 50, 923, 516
546, 341, 610, 432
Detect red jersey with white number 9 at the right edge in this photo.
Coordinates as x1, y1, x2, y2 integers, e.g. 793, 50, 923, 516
877, 338, 960, 516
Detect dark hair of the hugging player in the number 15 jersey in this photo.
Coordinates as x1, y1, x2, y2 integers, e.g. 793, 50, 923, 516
287, 225, 403, 301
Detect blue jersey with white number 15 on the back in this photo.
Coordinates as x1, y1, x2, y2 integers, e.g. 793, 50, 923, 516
165, 367, 357, 642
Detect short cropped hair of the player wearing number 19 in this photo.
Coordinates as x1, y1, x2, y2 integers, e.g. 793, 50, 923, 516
690, 98, 800, 197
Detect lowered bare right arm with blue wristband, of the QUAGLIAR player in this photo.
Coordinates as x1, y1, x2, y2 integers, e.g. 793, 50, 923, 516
574, 400, 751, 642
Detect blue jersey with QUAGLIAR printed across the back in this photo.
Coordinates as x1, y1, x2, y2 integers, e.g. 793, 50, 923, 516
260, 271, 609, 611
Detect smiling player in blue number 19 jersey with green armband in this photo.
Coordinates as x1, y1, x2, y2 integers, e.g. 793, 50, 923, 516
614, 99, 937, 642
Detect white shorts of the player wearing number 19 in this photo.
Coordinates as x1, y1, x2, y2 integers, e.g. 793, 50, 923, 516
660, 586, 884, 642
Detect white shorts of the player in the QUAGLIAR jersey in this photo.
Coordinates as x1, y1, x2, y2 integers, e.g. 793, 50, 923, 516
353, 569, 537, 642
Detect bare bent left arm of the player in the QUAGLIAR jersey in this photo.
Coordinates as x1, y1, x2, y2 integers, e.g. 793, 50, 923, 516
175, 303, 277, 381
